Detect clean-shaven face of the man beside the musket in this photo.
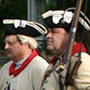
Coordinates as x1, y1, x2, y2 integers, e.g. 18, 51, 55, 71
46, 28, 69, 55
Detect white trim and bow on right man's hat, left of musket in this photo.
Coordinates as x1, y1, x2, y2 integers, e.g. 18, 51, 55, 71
42, 10, 73, 24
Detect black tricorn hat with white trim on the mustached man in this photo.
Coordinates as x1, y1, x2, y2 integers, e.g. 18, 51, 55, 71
3, 19, 47, 37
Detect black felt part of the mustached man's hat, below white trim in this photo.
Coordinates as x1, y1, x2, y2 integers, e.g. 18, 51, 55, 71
4, 24, 41, 37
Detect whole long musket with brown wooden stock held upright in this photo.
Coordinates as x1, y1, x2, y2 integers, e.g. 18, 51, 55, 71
59, 0, 83, 90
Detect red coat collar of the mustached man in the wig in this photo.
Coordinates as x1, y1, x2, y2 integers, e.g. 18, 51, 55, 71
9, 49, 38, 77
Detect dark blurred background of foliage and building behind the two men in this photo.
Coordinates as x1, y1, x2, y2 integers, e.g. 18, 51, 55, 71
0, 0, 90, 65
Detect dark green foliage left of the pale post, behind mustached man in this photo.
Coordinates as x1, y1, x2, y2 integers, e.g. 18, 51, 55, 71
0, 0, 27, 50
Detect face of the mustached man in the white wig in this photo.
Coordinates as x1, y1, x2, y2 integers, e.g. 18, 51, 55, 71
5, 35, 23, 62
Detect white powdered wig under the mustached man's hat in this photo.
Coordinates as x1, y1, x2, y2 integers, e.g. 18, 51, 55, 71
16, 34, 38, 49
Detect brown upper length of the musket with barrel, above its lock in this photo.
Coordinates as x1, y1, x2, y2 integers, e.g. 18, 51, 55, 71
63, 0, 83, 63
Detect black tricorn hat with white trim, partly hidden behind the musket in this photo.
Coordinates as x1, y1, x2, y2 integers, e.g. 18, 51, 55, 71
42, 7, 90, 32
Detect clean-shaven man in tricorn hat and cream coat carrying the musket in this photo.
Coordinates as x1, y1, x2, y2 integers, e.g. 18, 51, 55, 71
41, 8, 90, 90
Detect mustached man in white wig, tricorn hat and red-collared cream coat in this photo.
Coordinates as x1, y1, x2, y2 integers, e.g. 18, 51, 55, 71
0, 19, 48, 90
